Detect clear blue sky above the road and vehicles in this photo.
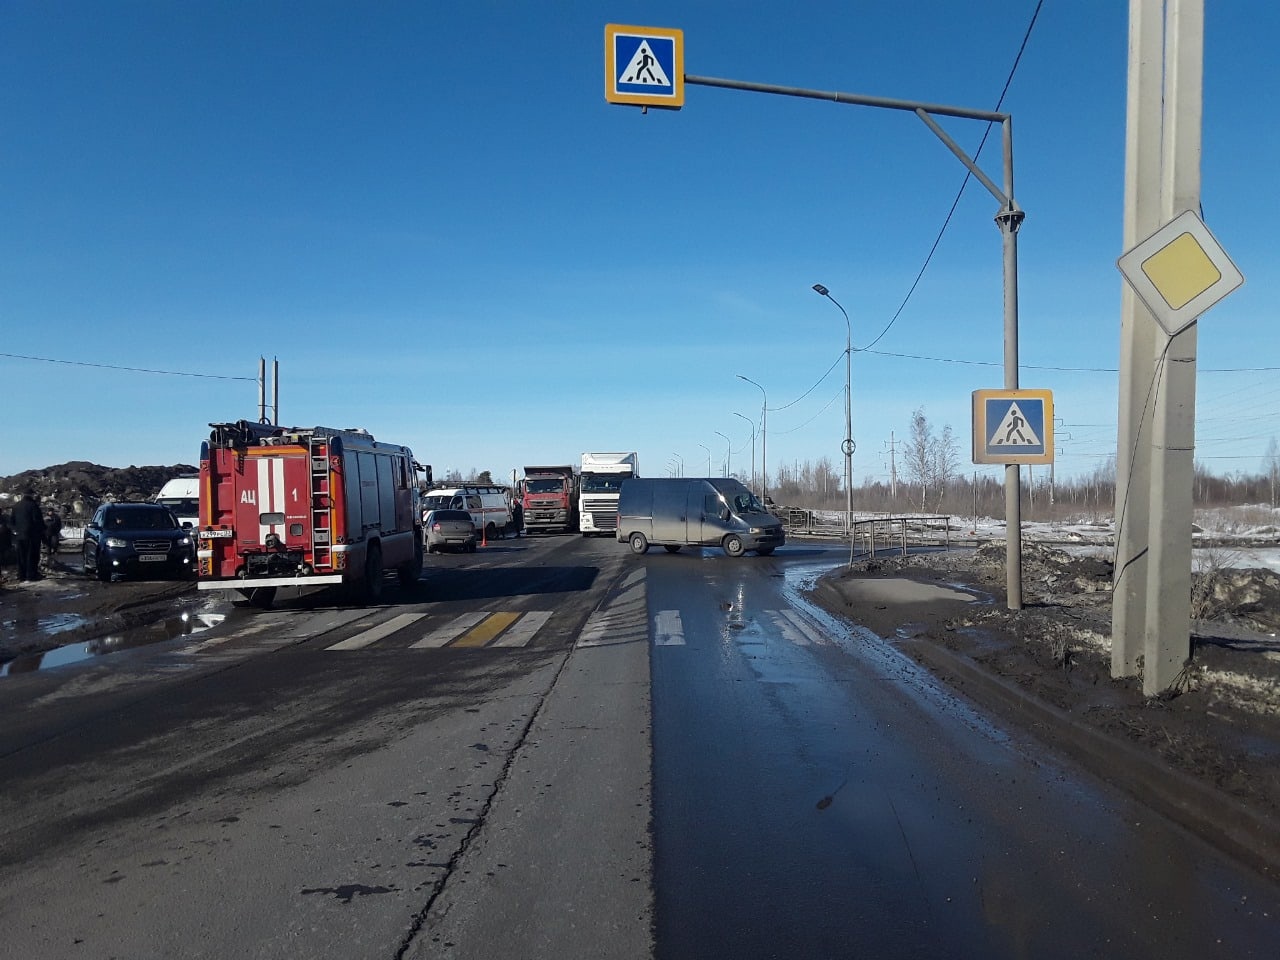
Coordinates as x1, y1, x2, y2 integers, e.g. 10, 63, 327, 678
0, 0, 1280, 485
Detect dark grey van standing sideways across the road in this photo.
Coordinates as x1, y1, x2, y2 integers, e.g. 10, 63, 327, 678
618, 476, 786, 557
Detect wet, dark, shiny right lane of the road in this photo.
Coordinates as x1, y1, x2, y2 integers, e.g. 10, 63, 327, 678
646, 553, 1280, 960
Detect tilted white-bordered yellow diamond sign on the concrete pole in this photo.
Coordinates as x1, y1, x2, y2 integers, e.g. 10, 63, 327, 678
1116, 210, 1244, 337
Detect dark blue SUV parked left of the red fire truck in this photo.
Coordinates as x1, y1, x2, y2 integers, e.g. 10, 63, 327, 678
83, 503, 196, 581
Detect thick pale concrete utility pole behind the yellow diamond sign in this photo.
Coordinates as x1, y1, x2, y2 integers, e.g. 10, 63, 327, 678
1111, 0, 1204, 696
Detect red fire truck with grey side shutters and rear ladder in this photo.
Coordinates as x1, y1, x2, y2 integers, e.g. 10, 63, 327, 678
197, 420, 431, 607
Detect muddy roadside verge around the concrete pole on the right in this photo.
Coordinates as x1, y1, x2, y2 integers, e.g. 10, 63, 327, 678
814, 544, 1280, 839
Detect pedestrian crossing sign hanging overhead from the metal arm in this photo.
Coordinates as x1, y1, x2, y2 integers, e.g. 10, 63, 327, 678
604, 23, 685, 110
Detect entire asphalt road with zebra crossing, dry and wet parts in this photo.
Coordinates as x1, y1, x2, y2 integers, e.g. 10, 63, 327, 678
0, 538, 1280, 960
